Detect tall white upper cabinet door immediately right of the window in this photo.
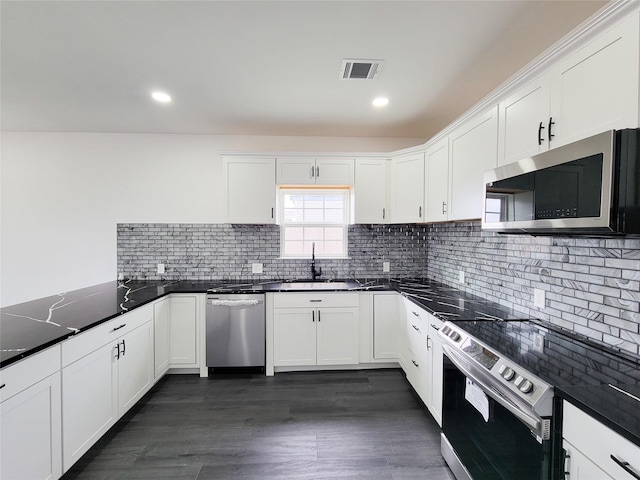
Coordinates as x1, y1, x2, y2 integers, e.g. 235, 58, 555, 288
354, 158, 389, 223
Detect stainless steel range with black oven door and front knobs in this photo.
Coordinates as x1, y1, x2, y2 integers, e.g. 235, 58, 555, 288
439, 322, 554, 480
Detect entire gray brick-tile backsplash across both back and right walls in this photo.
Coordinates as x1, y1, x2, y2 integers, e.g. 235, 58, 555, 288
117, 222, 640, 355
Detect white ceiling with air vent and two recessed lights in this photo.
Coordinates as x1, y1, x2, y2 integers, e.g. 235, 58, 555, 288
0, 0, 606, 139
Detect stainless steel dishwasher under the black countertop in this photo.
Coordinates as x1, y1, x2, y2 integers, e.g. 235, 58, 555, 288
206, 294, 266, 368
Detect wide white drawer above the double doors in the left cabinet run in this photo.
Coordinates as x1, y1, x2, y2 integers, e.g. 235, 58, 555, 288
62, 304, 153, 367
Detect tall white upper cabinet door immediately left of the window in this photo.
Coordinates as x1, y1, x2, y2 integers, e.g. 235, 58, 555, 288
223, 157, 276, 224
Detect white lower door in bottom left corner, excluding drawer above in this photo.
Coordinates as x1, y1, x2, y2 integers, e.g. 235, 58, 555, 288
0, 374, 62, 480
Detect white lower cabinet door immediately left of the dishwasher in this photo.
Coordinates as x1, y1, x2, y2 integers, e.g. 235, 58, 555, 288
169, 295, 199, 367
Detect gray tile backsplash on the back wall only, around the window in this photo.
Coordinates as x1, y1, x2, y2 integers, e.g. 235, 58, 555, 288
117, 223, 427, 281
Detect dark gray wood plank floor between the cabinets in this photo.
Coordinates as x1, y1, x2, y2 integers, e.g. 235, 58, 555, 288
63, 370, 454, 480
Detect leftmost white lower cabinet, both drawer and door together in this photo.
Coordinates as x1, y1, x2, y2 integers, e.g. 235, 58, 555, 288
0, 346, 62, 480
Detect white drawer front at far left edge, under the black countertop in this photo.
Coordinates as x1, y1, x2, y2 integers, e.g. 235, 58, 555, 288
0, 345, 60, 402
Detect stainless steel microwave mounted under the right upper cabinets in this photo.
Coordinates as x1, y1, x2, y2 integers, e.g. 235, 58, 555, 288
482, 129, 640, 236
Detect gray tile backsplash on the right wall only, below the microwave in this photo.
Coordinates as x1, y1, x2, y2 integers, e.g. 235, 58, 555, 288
427, 222, 640, 355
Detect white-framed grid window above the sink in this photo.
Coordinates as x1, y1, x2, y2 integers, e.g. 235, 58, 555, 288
279, 188, 349, 258
